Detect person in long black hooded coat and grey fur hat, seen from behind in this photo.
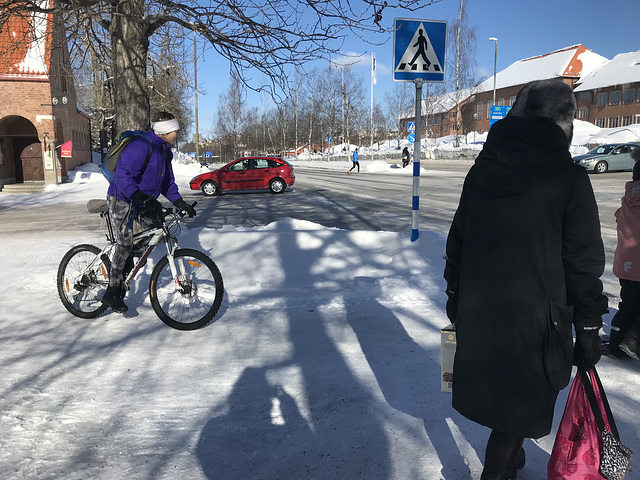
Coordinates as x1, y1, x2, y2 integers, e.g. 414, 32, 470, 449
444, 80, 607, 480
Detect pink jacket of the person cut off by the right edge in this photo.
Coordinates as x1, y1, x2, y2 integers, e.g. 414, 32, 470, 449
613, 180, 640, 282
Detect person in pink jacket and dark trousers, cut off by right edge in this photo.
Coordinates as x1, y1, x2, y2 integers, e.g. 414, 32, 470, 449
609, 149, 640, 360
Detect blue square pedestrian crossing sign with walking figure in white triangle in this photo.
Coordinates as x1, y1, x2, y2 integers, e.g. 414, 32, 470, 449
393, 18, 447, 82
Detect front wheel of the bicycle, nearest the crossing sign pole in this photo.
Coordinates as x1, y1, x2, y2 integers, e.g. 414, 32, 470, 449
149, 248, 224, 330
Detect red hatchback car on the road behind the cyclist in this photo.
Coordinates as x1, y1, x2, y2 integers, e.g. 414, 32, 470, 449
189, 157, 296, 197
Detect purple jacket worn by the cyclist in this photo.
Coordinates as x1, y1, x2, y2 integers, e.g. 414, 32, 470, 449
107, 130, 182, 203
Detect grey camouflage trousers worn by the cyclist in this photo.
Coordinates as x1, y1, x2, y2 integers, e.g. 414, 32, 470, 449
107, 196, 157, 287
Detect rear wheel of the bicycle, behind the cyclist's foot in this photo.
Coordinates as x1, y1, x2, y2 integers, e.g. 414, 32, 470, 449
57, 245, 110, 318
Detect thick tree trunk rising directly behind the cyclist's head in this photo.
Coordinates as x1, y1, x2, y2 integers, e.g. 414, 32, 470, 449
111, 0, 150, 132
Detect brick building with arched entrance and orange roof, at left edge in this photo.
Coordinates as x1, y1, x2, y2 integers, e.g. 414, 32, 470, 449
0, 7, 91, 189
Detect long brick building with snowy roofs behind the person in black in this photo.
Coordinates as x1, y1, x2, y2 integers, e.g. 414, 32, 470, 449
403, 45, 640, 142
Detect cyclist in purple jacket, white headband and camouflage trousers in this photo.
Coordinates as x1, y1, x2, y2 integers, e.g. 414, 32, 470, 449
102, 112, 196, 313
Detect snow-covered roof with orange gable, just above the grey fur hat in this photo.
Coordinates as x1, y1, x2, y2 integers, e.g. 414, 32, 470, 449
476, 45, 608, 93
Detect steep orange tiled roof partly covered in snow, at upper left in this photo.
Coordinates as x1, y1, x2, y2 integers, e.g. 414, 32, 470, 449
0, 0, 52, 78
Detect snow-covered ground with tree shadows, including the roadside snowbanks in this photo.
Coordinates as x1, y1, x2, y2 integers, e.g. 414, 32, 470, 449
0, 122, 640, 480
